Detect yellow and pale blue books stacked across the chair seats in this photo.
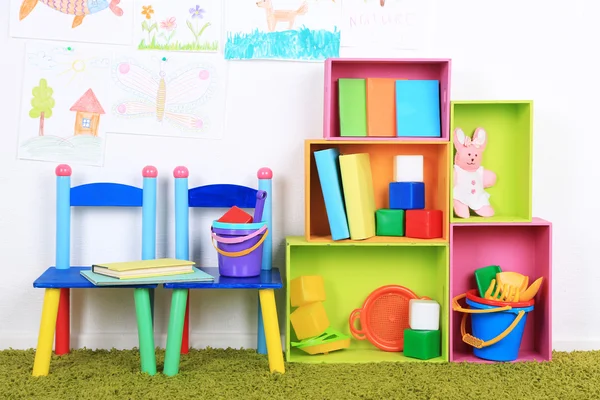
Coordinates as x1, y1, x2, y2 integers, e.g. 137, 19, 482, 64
81, 258, 214, 286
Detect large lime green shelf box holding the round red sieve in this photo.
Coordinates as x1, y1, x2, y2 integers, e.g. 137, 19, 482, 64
285, 237, 450, 363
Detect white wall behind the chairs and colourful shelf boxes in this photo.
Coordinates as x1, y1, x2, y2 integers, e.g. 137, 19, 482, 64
0, 0, 600, 350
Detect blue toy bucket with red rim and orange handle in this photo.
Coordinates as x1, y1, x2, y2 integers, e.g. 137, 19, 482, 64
453, 289, 534, 361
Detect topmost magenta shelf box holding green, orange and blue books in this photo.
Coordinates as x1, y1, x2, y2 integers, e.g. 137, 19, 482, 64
323, 58, 451, 142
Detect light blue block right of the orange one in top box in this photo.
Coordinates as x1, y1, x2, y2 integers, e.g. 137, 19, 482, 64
396, 79, 442, 137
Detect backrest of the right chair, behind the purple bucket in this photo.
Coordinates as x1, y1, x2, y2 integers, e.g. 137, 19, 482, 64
173, 166, 273, 270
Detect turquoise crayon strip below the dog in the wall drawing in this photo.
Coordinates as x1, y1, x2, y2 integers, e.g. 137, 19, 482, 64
224, 26, 340, 61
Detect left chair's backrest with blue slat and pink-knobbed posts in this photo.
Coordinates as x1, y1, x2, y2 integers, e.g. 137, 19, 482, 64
56, 164, 158, 269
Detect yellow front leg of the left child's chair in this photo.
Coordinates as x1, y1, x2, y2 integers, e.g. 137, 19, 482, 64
33, 289, 60, 376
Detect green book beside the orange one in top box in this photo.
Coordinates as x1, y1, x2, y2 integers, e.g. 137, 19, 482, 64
338, 78, 367, 136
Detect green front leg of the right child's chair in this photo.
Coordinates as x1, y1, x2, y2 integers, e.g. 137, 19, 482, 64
163, 289, 188, 376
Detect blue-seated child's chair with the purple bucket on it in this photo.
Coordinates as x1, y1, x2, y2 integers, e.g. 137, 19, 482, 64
163, 167, 284, 375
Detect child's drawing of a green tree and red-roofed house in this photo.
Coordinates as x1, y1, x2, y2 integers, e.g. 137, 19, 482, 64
18, 43, 112, 166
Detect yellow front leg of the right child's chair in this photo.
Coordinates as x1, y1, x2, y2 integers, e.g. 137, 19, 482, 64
258, 289, 285, 374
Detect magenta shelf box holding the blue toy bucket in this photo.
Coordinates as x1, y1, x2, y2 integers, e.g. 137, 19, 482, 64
450, 218, 552, 363
